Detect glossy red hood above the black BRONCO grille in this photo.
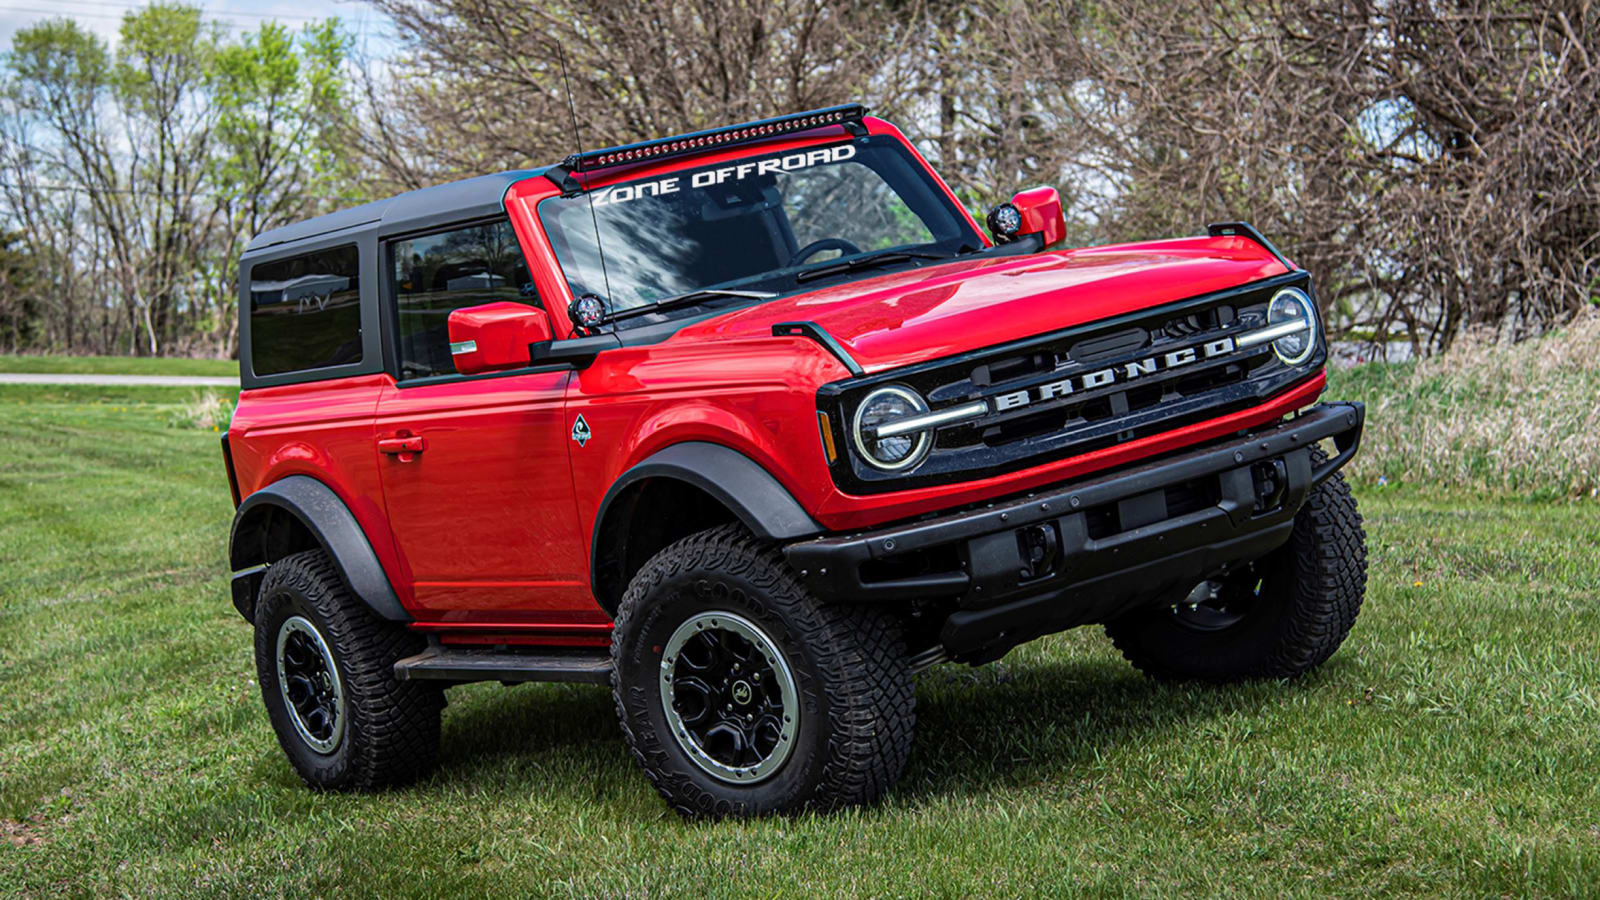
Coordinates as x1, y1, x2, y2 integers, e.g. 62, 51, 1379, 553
677, 237, 1286, 373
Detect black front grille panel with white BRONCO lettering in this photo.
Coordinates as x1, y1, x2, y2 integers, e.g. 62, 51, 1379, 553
819, 272, 1323, 493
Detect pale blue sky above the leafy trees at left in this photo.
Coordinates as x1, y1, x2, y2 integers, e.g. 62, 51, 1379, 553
0, 0, 392, 56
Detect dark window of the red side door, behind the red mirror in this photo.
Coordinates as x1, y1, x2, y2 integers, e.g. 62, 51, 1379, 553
389, 221, 539, 380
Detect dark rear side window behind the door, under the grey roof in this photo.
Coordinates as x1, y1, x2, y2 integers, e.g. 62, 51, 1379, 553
250, 245, 362, 375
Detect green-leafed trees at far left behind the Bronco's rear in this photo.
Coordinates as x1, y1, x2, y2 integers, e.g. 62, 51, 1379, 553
0, 3, 363, 354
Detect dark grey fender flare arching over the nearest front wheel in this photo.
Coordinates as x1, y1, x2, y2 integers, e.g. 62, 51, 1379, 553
589, 440, 824, 599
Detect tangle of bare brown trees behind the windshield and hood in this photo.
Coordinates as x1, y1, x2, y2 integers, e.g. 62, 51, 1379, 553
366, 0, 1600, 351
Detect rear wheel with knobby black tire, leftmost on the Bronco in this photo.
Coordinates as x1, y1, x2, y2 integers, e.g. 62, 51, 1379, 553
256, 549, 445, 790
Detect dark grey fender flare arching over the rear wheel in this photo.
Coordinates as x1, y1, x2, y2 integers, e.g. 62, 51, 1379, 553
227, 476, 411, 621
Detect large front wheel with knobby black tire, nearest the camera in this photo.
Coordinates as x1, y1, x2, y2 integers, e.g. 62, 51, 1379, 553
611, 525, 915, 817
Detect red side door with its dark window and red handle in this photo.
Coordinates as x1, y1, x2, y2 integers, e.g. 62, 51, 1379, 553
376, 221, 608, 631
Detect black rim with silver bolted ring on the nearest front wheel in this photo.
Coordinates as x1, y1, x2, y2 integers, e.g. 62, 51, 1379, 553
661, 612, 800, 785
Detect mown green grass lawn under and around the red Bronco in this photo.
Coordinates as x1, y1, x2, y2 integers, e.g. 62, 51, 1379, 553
0, 381, 1600, 897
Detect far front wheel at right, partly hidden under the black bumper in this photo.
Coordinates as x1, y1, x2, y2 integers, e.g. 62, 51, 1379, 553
1106, 455, 1366, 682
